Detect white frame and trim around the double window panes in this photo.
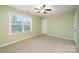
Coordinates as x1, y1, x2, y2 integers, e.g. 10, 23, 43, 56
9, 12, 32, 35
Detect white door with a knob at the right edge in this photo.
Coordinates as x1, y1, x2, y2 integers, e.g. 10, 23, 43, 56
73, 12, 79, 48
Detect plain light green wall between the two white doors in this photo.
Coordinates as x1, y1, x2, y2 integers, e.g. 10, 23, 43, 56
47, 12, 74, 40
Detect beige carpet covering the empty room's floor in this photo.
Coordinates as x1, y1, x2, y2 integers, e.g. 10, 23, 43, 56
0, 35, 77, 53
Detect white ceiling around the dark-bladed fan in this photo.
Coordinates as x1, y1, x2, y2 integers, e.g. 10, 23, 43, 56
9, 5, 76, 17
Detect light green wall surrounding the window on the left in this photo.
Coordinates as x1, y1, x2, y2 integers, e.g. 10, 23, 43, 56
0, 6, 41, 45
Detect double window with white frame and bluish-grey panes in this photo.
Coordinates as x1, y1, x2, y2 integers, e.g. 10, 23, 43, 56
10, 14, 32, 34
